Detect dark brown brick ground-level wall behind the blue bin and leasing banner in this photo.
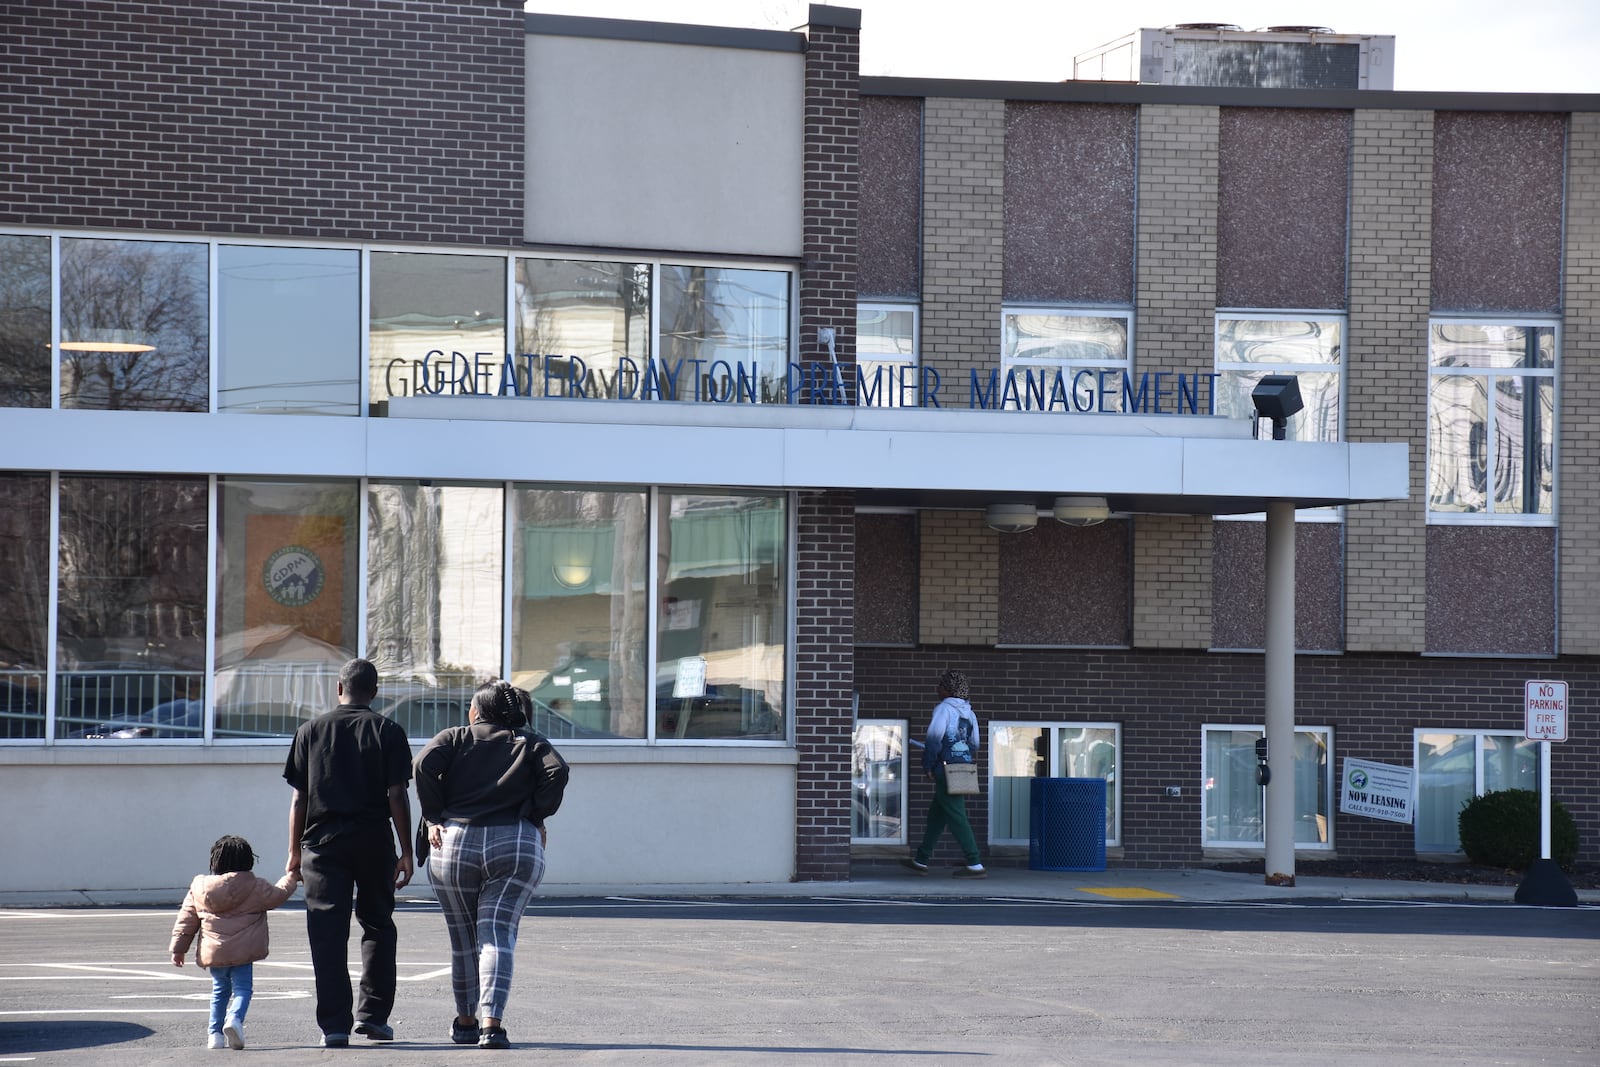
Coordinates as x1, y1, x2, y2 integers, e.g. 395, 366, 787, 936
853, 648, 1600, 867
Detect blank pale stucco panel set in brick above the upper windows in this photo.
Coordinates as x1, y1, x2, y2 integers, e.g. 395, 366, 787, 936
525, 35, 805, 258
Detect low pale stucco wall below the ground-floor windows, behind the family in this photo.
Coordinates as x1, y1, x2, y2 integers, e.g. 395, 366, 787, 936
0, 742, 795, 901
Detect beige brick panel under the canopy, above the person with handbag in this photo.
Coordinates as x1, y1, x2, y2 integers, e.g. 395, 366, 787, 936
917, 510, 1000, 645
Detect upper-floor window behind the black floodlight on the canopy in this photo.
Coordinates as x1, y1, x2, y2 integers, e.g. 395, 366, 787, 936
1216, 312, 1344, 442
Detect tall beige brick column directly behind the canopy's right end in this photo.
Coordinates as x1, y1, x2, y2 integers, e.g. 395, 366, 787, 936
1344, 109, 1434, 653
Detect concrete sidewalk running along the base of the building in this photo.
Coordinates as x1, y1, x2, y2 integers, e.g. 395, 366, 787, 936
0, 862, 1600, 909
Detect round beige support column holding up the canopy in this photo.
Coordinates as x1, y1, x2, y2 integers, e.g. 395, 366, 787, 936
1266, 501, 1294, 886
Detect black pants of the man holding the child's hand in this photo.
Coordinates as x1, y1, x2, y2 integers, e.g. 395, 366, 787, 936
301, 822, 398, 1035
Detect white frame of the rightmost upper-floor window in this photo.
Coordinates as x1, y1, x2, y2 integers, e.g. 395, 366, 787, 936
1422, 314, 1562, 526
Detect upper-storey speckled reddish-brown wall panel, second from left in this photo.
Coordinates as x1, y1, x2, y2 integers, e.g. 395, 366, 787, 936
1005, 102, 1138, 307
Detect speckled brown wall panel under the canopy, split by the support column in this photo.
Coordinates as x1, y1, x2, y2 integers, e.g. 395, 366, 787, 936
1211, 520, 1344, 653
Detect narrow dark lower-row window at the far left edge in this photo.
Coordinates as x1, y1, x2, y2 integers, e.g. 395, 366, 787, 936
0, 473, 50, 737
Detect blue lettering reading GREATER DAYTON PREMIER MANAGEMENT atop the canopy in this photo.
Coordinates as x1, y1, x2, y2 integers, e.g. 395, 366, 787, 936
374, 350, 1218, 414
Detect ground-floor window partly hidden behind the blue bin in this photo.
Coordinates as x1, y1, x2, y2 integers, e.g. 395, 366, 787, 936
989, 723, 1122, 845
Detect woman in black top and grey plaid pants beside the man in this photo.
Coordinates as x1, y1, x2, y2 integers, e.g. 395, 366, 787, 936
414, 681, 565, 1048
